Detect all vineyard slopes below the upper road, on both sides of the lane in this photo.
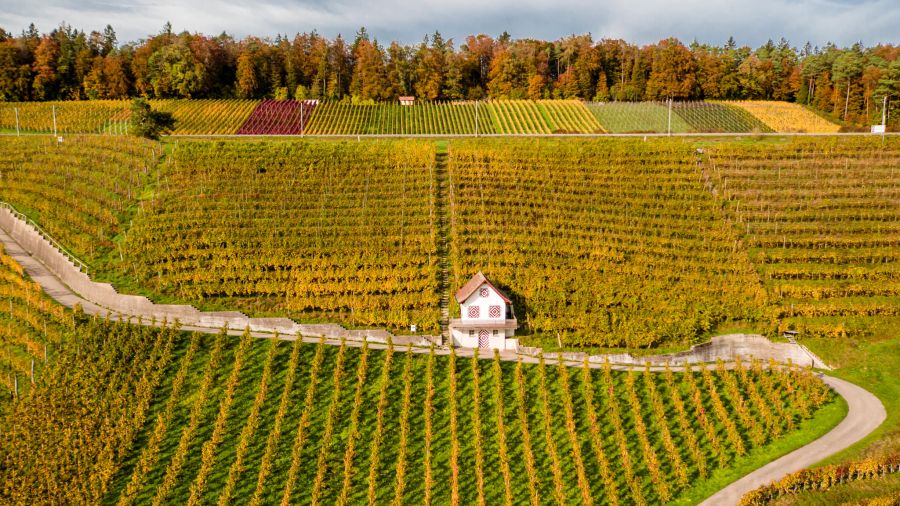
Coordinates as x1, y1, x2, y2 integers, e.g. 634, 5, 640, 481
0, 132, 900, 504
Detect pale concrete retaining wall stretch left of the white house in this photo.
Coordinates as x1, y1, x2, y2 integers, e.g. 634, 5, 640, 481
0, 208, 442, 346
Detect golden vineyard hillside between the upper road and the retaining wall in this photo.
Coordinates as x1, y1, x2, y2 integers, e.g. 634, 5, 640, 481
0, 133, 900, 348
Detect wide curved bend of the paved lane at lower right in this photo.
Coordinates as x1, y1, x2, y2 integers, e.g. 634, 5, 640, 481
700, 376, 887, 506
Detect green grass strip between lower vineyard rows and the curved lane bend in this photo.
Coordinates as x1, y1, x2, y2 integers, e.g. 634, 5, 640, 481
671, 397, 847, 505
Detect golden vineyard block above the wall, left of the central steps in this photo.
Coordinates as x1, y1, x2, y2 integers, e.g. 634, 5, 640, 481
120, 141, 439, 332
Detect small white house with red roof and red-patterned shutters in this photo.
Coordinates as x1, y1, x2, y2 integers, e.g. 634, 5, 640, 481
450, 272, 519, 350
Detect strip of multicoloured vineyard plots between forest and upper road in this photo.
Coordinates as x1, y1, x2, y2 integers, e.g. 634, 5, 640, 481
0, 100, 839, 136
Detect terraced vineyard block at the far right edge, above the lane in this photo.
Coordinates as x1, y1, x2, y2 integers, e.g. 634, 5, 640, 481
705, 138, 900, 337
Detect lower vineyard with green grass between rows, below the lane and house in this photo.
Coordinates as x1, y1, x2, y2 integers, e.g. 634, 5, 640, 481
0, 308, 834, 505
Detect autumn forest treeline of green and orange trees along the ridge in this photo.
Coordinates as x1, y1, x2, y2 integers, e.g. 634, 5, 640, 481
0, 24, 900, 124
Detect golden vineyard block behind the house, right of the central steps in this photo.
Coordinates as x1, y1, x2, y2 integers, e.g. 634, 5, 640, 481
449, 139, 765, 347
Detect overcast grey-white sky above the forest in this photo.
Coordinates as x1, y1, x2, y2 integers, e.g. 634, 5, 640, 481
0, 0, 900, 46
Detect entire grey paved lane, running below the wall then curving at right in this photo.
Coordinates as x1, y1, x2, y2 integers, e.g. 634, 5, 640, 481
0, 229, 887, 506
